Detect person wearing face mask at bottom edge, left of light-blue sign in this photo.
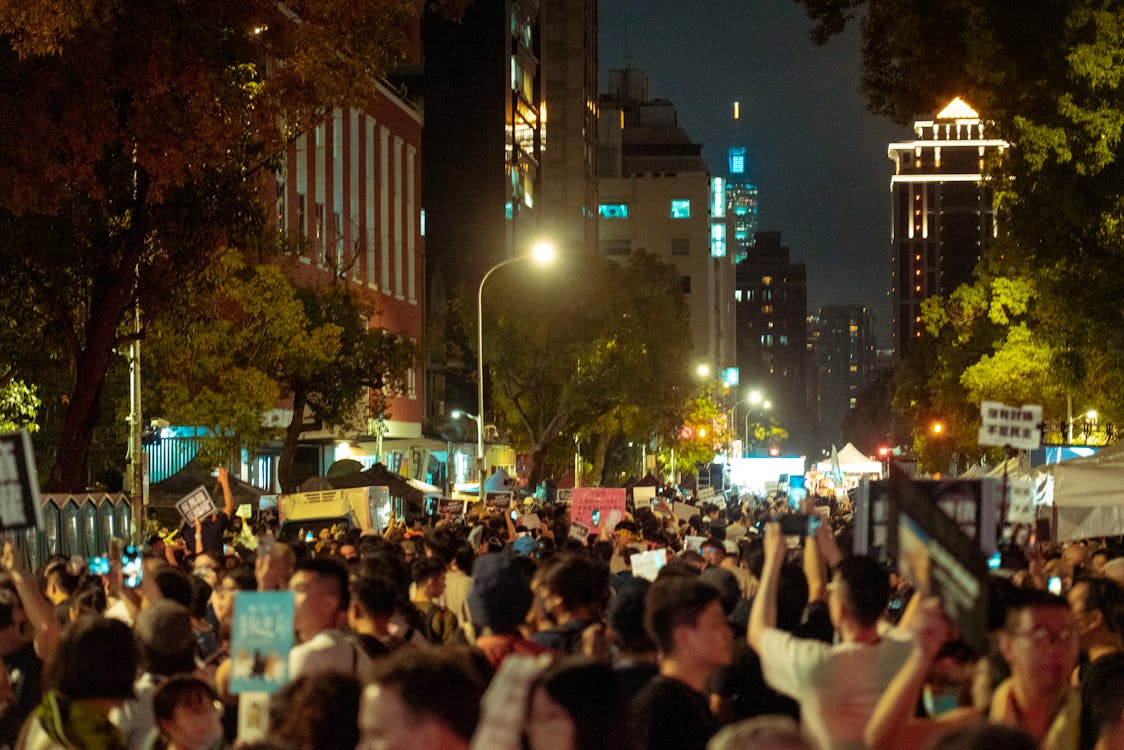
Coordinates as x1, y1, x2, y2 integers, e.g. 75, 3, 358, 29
146, 675, 225, 750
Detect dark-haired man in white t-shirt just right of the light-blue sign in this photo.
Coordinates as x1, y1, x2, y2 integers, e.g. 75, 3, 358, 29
289, 558, 372, 680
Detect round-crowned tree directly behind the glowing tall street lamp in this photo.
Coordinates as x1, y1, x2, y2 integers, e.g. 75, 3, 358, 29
481, 253, 690, 485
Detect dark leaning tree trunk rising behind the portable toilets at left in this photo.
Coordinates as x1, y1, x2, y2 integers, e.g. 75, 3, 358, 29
46, 268, 133, 493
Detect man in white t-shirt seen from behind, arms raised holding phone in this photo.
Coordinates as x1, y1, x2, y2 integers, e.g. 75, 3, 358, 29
749, 523, 912, 750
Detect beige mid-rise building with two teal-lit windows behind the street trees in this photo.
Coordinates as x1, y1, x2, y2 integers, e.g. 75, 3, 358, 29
598, 69, 734, 369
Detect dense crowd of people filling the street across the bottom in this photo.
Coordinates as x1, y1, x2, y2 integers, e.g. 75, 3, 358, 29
0, 472, 1124, 750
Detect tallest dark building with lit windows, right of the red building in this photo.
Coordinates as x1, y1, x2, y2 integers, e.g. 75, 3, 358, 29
411, 0, 598, 423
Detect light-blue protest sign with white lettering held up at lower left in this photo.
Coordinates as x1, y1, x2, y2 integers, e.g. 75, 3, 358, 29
230, 591, 293, 694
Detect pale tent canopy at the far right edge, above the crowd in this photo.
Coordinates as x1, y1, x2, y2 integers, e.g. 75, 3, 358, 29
1049, 443, 1124, 541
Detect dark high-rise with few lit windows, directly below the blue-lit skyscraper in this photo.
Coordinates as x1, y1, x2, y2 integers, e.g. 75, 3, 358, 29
734, 232, 816, 450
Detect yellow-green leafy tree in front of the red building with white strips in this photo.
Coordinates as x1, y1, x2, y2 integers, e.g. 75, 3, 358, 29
144, 253, 415, 491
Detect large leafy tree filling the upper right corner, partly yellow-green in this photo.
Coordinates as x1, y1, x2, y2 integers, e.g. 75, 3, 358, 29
804, 0, 1124, 445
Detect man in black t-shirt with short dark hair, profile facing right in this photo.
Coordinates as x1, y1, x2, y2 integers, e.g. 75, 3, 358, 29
633, 576, 733, 750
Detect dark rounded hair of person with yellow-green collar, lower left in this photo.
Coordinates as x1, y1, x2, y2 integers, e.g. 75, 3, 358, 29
43, 615, 138, 699
